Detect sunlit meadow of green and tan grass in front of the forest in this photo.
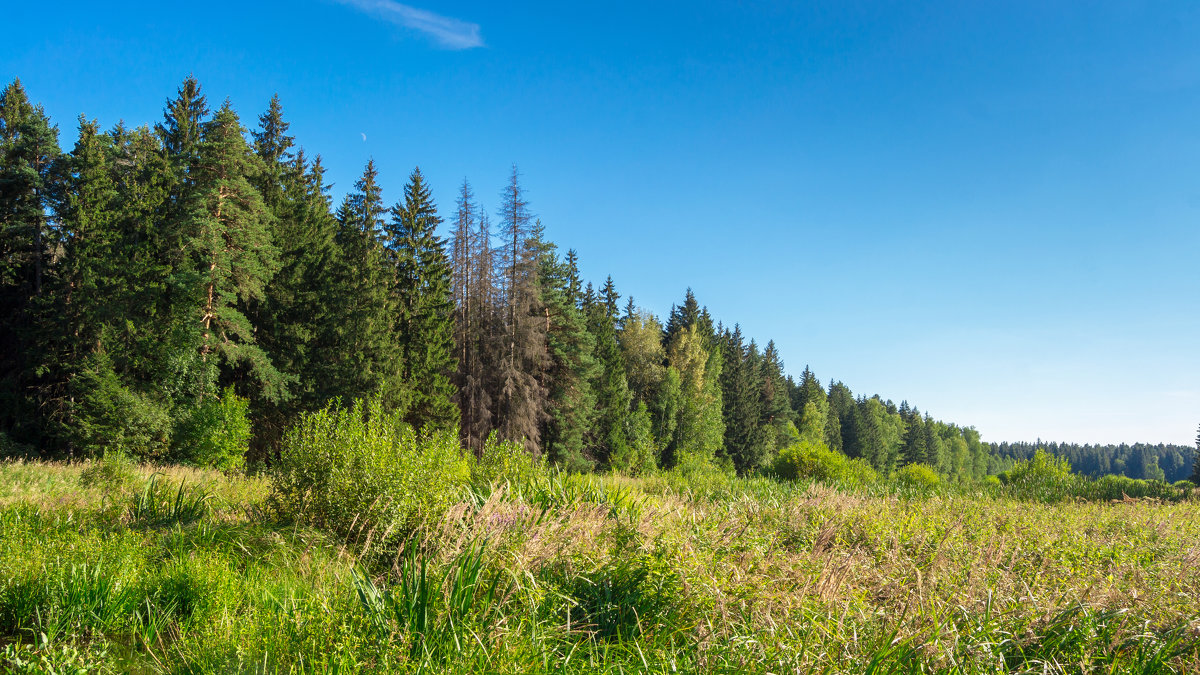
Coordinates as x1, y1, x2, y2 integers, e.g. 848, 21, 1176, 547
0, 454, 1200, 674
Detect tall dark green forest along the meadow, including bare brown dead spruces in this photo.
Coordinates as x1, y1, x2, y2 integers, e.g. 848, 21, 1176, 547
0, 78, 1186, 479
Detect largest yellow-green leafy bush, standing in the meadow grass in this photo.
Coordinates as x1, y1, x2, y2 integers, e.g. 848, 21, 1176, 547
268, 400, 468, 548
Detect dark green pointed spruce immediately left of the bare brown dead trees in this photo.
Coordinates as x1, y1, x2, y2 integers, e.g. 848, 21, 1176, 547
386, 168, 460, 429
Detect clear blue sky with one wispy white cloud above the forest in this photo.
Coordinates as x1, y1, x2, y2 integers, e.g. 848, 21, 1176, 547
0, 0, 1200, 443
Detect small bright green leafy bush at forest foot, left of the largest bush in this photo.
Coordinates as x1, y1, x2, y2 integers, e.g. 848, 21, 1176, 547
175, 387, 251, 471
